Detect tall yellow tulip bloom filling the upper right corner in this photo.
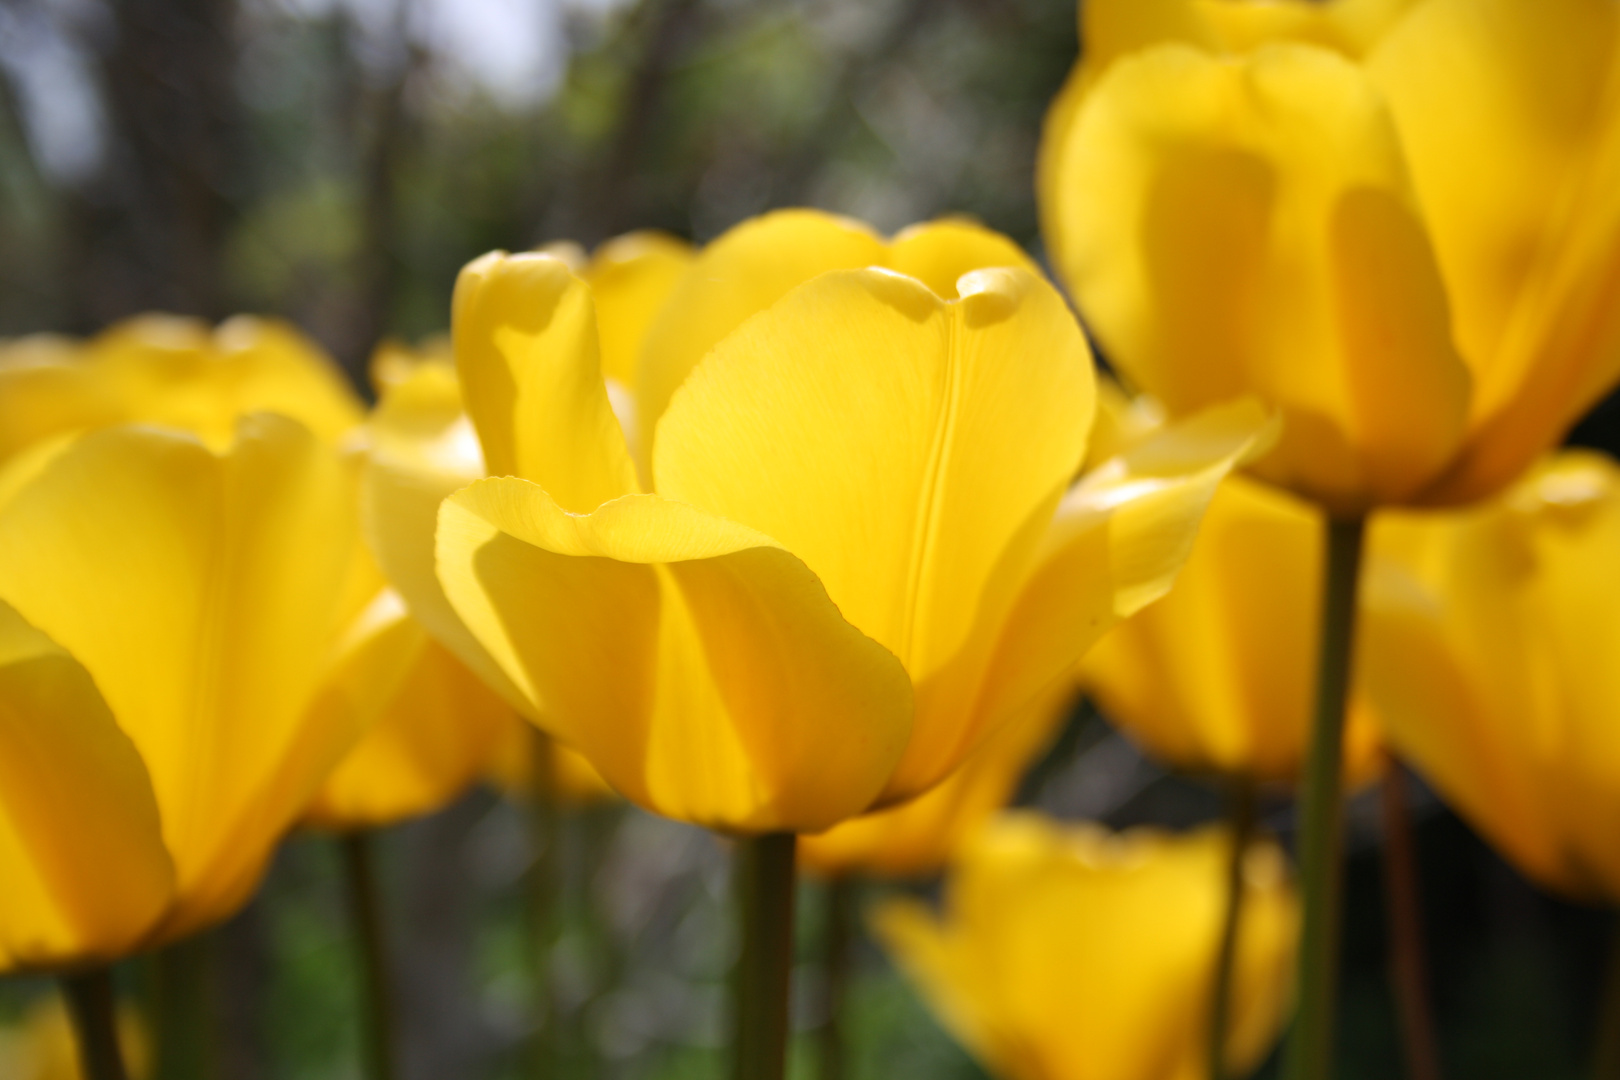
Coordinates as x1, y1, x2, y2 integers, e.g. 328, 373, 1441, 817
1040, 0, 1620, 513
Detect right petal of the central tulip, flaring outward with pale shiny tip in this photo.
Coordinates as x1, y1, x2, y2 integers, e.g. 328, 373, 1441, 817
974, 402, 1275, 786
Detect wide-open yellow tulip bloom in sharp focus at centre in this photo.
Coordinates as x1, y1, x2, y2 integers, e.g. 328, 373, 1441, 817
382, 212, 1264, 832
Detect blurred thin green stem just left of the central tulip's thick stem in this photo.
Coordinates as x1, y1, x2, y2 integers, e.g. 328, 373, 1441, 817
528, 729, 561, 1080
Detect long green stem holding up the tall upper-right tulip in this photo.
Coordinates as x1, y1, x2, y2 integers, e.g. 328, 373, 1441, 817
1283, 518, 1362, 1080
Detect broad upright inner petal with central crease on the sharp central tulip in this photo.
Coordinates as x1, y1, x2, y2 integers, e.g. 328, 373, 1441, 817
653, 270, 1094, 680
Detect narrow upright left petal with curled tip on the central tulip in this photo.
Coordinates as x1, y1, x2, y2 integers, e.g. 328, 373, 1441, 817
450, 251, 638, 513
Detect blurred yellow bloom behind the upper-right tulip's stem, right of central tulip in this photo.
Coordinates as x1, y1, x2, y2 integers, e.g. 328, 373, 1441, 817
1081, 476, 1379, 780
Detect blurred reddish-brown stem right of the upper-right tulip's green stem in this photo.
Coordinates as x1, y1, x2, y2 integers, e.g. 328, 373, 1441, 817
1379, 755, 1440, 1080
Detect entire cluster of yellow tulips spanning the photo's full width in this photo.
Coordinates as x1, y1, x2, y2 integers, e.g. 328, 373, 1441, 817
0, 0, 1620, 1080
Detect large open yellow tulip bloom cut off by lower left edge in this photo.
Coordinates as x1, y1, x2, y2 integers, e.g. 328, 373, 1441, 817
0, 416, 360, 967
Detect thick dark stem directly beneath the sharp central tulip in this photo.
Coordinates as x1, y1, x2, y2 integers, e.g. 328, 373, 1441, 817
732, 832, 797, 1080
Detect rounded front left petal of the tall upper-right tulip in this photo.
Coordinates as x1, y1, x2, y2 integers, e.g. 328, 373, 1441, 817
1047, 45, 1469, 513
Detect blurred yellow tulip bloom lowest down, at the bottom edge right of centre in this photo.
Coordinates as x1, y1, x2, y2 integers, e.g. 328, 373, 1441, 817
873, 813, 1299, 1080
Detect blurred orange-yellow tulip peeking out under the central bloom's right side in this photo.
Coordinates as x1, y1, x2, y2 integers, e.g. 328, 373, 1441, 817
799, 680, 1076, 878
